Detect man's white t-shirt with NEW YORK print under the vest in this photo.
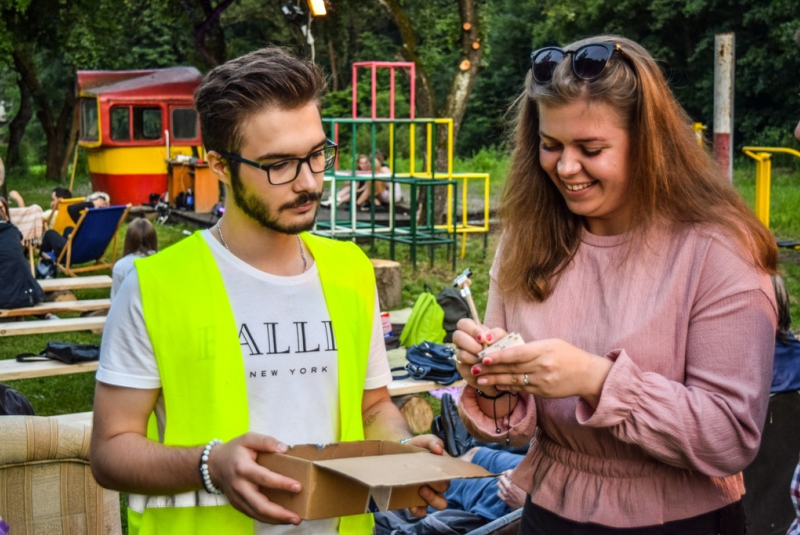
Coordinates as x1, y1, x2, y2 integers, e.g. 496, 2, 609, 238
97, 231, 392, 535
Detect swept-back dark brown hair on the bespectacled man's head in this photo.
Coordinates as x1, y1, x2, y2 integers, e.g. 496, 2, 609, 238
194, 47, 325, 160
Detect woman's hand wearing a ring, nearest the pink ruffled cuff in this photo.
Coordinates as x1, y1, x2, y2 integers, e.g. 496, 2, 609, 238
476, 338, 612, 408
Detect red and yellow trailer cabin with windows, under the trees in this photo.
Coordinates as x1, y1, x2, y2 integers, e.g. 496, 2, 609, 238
78, 67, 203, 205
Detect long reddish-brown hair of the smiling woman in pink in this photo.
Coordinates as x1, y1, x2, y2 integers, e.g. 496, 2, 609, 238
498, 35, 778, 301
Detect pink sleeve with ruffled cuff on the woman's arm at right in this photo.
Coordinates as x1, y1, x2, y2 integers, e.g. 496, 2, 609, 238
576, 241, 777, 477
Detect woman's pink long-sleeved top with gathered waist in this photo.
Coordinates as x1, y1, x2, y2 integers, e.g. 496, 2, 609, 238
461, 225, 777, 527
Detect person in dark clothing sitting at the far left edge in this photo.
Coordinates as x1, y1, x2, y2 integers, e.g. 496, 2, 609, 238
0, 197, 44, 308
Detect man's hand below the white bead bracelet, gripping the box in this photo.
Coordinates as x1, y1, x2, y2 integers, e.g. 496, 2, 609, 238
208, 433, 302, 525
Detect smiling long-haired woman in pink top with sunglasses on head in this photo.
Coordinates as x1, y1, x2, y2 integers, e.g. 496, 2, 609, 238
454, 36, 777, 535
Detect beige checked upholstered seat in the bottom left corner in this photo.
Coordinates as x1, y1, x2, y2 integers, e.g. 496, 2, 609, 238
0, 416, 122, 535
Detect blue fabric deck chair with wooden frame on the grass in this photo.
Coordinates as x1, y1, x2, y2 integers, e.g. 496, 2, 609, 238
57, 204, 131, 277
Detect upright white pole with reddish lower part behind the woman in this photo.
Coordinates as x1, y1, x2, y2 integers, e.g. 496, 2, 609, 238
714, 33, 736, 182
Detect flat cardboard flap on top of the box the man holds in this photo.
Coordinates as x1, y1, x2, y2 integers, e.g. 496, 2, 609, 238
314, 453, 495, 487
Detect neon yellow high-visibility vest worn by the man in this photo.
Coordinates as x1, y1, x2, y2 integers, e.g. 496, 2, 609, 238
128, 233, 375, 535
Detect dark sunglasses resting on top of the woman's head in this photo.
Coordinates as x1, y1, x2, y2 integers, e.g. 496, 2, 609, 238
531, 43, 622, 84
